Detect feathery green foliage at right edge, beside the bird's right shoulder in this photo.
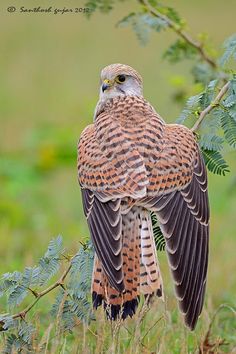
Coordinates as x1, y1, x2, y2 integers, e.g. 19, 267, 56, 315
177, 76, 236, 175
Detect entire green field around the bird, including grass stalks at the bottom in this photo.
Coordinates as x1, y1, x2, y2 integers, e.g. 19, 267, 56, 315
0, 0, 236, 353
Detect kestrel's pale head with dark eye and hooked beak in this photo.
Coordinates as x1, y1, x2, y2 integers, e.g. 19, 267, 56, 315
100, 64, 143, 101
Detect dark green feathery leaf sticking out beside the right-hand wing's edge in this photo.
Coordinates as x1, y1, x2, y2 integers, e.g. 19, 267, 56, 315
201, 149, 229, 176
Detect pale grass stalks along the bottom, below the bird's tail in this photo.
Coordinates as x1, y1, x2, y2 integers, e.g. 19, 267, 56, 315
0, 301, 235, 354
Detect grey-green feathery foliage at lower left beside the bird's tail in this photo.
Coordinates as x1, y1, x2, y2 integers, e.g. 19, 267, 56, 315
0, 236, 94, 353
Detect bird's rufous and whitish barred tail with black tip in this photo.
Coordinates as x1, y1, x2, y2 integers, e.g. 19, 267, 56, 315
92, 207, 162, 320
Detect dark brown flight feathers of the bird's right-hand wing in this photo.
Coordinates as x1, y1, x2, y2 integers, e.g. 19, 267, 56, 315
146, 149, 209, 329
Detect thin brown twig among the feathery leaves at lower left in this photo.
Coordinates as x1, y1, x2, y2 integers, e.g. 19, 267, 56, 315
12, 257, 74, 320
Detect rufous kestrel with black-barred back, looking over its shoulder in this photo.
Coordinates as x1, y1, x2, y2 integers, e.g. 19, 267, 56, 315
78, 64, 209, 330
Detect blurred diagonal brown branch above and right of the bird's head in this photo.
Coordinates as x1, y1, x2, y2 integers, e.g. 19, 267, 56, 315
138, 0, 217, 69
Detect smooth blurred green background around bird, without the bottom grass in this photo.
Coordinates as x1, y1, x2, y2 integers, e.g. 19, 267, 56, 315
0, 0, 236, 318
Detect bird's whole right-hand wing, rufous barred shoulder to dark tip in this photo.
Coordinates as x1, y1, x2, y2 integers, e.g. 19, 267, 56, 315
143, 126, 209, 329
